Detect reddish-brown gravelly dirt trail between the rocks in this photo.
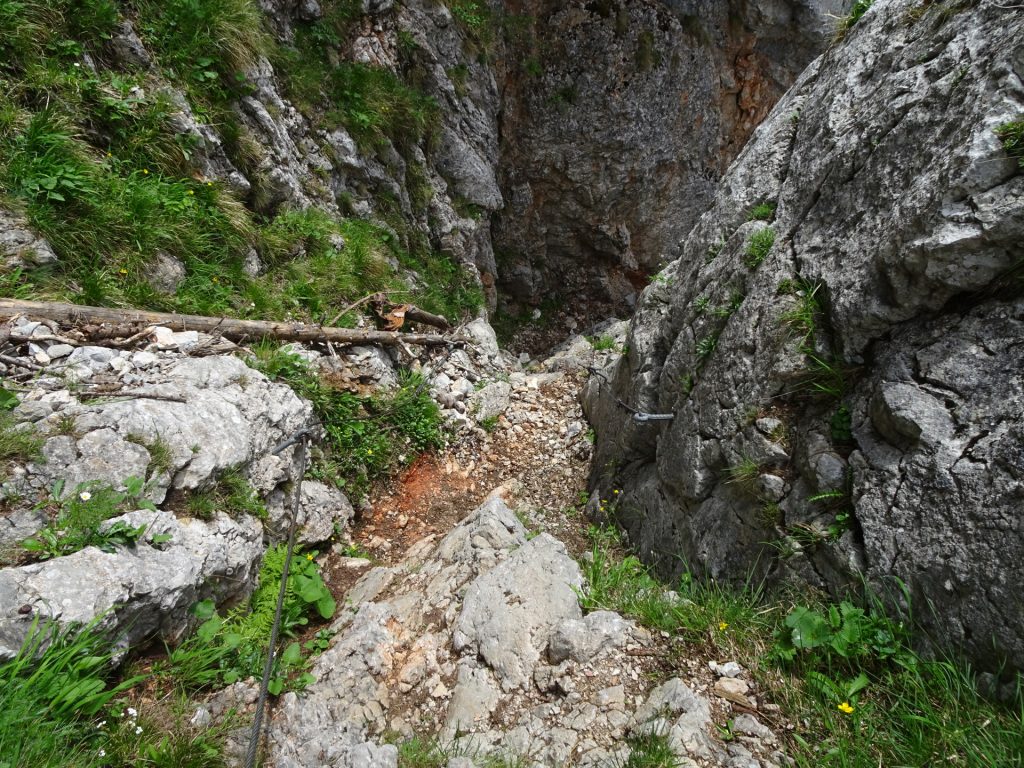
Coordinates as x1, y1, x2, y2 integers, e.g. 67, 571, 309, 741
329, 372, 591, 589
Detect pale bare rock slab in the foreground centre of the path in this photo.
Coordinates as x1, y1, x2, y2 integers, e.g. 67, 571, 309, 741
264, 497, 774, 768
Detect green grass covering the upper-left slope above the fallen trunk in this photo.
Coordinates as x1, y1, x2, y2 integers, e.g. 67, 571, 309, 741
0, 0, 482, 324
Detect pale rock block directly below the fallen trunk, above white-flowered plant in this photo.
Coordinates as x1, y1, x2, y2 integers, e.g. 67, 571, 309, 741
9, 354, 311, 504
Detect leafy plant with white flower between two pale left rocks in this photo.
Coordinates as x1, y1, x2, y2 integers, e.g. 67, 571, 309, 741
22, 477, 160, 560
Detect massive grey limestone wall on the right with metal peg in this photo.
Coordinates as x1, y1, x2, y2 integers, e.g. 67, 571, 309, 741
587, 0, 1024, 669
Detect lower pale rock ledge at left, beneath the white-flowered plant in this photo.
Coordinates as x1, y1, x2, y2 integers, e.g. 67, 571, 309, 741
0, 510, 263, 658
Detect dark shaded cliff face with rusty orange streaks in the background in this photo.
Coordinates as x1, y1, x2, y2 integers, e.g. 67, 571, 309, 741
496, 0, 842, 313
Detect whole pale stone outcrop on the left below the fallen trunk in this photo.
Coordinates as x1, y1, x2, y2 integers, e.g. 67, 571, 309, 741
0, 318, 323, 657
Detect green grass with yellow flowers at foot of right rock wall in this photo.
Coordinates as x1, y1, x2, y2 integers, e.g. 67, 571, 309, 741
581, 529, 1024, 768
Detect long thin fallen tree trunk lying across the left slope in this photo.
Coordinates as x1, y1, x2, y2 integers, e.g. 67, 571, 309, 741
0, 299, 461, 346
